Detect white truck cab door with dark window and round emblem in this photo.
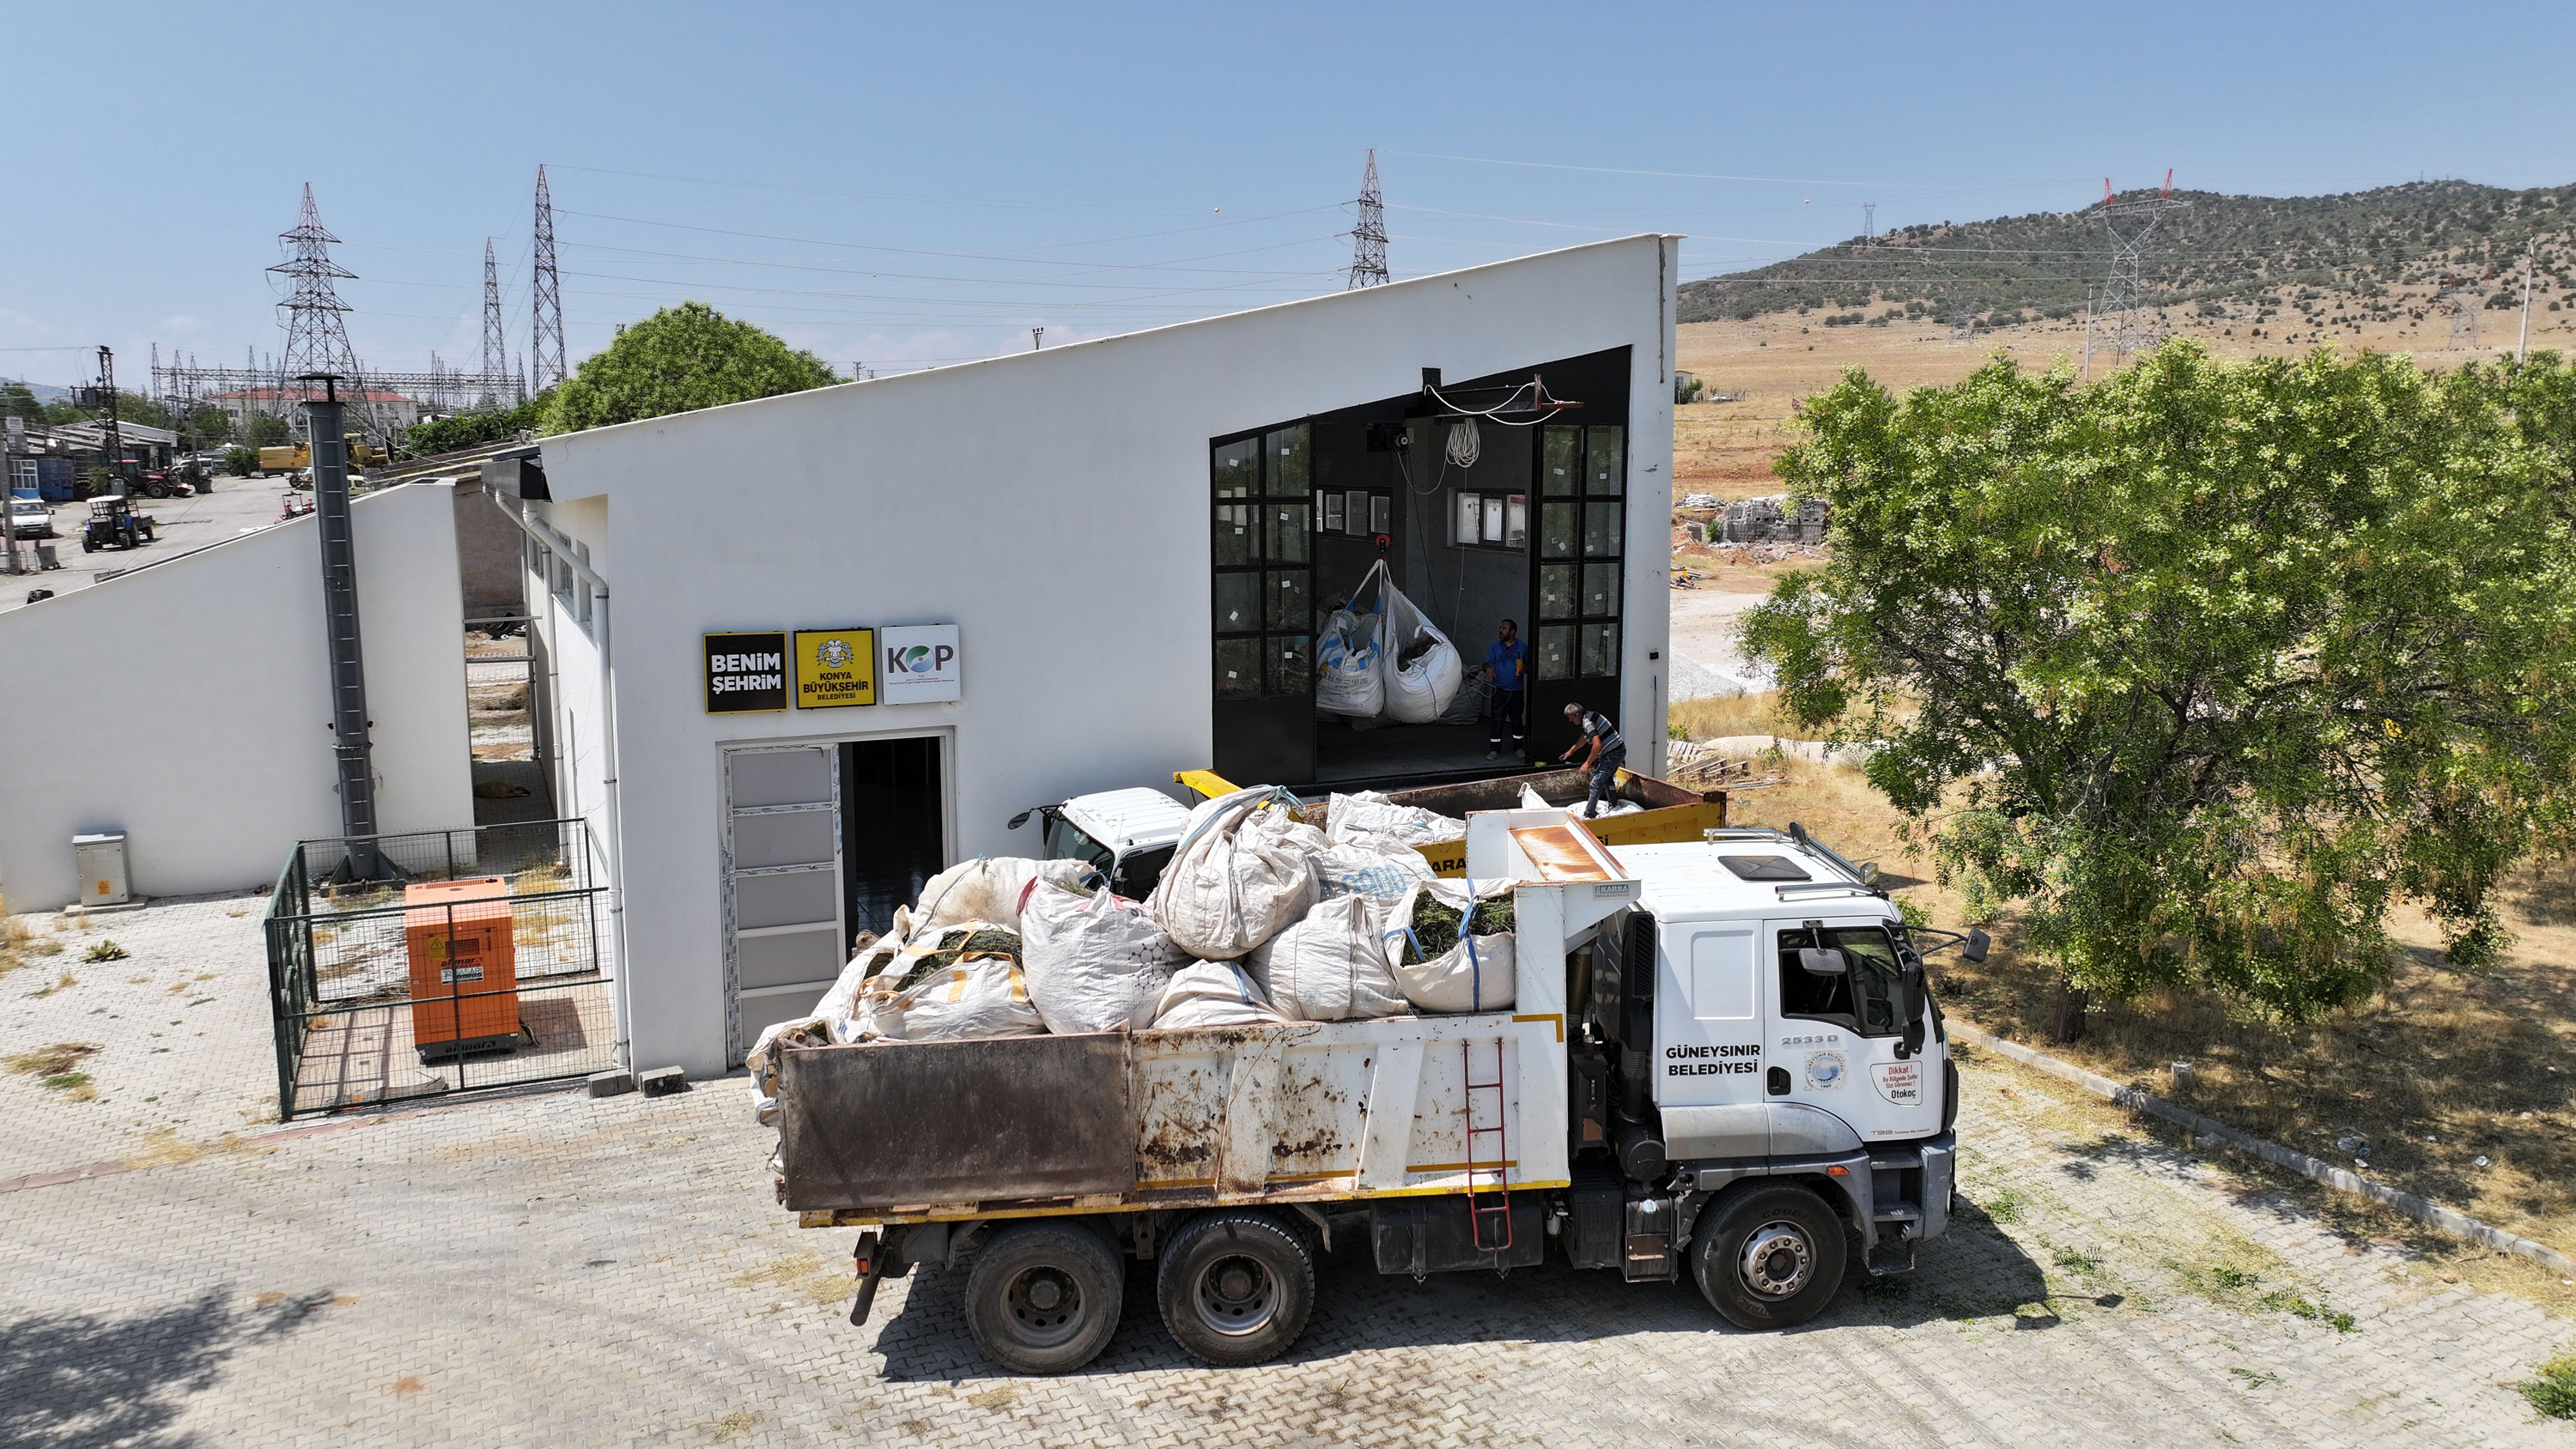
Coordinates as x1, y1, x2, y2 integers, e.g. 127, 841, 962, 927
1757, 916, 1940, 1143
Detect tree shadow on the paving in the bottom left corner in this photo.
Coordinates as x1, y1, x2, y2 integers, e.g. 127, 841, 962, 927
0, 1287, 332, 1449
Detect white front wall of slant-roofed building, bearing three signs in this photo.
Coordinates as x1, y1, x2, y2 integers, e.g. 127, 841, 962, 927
538, 237, 1672, 1073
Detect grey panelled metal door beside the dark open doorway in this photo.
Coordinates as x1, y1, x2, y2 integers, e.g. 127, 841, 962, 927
724, 743, 848, 1063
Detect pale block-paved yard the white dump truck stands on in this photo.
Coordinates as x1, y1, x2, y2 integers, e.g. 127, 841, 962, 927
0, 903, 2576, 1449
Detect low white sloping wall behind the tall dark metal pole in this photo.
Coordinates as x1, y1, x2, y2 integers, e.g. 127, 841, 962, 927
0, 484, 474, 911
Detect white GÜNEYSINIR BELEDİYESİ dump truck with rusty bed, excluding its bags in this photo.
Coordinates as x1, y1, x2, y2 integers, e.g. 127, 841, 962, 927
778, 808, 1986, 1374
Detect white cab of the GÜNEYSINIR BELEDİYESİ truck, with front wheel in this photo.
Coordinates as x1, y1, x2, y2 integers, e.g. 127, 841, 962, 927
1574, 831, 1984, 1302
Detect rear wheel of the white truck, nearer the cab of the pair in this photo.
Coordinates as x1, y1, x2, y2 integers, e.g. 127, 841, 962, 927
1157, 1212, 1314, 1369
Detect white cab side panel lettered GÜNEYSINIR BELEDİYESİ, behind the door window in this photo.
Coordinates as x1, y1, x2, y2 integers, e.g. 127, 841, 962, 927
1654, 921, 1765, 1109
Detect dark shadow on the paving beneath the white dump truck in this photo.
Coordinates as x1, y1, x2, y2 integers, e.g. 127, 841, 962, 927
876, 1199, 2056, 1382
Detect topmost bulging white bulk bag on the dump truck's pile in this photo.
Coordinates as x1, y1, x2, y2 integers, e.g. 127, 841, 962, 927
1146, 785, 1324, 960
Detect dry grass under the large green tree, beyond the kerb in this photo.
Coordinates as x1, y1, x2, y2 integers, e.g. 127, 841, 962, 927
1726, 741, 2576, 1266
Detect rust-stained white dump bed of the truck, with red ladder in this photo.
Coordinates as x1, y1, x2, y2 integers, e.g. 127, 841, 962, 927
778, 880, 1633, 1228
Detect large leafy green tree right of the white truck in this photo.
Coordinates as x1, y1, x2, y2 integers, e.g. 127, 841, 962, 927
1747, 343, 2576, 1037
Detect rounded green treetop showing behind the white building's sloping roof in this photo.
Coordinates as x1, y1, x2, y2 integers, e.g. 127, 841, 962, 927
546, 301, 837, 433
